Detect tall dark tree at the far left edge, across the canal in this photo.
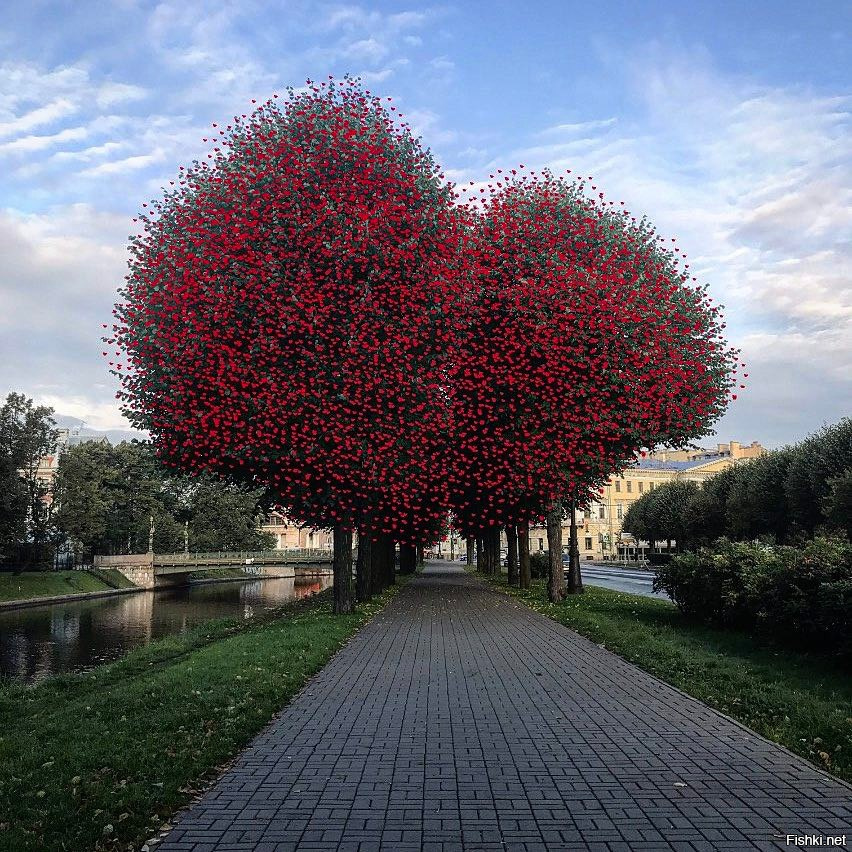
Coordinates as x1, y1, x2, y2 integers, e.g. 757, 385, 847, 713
0, 393, 58, 566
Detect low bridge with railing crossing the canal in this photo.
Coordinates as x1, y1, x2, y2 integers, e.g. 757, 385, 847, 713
94, 548, 332, 589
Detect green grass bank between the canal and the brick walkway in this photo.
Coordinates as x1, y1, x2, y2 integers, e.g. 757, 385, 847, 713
0, 584, 401, 852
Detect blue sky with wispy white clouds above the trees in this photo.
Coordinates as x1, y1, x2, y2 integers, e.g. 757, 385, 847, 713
0, 0, 852, 447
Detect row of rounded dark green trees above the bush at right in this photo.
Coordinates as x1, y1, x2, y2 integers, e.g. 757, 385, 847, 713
623, 418, 852, 550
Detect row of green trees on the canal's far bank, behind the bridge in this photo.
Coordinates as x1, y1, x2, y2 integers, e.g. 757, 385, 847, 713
0, 393, 273, 569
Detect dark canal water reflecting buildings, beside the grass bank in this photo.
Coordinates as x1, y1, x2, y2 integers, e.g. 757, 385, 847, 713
0, 574, 332, 683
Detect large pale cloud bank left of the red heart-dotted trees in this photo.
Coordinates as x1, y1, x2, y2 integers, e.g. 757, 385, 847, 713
0, 204, 130, 428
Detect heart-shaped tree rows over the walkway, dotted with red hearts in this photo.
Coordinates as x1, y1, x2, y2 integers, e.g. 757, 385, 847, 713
111, 79, 739, 612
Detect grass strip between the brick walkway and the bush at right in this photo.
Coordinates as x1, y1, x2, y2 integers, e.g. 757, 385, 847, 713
480, 575, 852, 781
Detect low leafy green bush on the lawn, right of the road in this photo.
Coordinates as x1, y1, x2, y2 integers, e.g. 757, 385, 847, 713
654, 536, 852, 656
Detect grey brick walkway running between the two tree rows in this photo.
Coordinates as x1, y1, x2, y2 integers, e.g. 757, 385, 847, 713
159, 565, 852, 852
